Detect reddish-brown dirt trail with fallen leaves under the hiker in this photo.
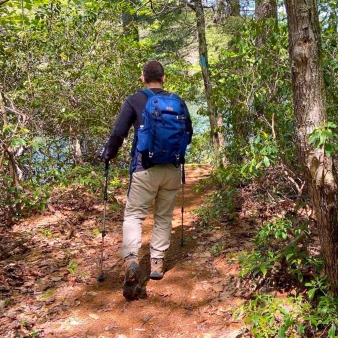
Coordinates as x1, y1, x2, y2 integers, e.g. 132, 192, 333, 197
0, 166, 250, 338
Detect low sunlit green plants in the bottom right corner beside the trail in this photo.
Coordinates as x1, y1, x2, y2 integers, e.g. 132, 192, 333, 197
238, 294, 338, 338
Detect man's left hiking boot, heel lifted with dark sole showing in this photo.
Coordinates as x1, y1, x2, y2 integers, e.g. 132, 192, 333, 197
123, 255, 142, 300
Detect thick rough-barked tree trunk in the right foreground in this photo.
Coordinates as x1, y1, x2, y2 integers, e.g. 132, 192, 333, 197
285, 0, 338, 296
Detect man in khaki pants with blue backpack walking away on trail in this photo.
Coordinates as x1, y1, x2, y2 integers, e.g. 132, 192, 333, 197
101, 61, 193, 299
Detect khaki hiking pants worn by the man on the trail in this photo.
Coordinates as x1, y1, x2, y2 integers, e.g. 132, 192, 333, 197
121, 164, 181, 258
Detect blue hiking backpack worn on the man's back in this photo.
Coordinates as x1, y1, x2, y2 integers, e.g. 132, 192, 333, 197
135, 89, 190, 167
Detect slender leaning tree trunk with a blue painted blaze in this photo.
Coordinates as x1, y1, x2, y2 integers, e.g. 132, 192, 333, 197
195, 0, 226, 165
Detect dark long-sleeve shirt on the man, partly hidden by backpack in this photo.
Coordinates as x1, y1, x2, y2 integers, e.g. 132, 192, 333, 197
103, 88, 193, 168
